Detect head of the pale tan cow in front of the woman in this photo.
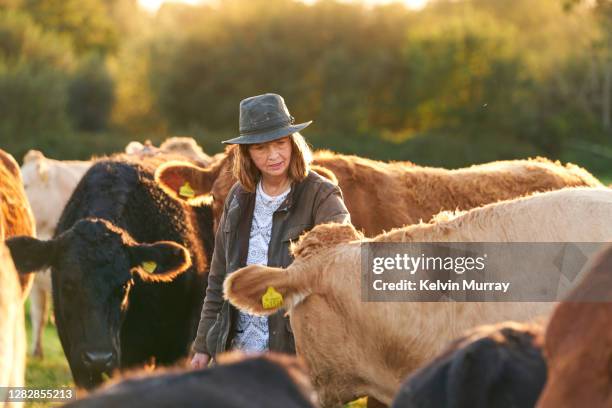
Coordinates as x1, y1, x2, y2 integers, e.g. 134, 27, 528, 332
224, 224, 376, 406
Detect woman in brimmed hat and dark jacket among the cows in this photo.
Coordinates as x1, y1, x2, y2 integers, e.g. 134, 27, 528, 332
191, 94, 350, 368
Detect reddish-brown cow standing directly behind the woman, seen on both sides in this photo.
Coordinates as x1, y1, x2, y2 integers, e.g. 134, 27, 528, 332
156, 147, 602, 236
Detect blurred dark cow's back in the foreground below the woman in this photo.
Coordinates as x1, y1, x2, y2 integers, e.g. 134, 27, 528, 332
66, 353, 316, 408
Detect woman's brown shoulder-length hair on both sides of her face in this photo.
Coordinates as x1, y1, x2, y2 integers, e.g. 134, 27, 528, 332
232, 132, 312, 193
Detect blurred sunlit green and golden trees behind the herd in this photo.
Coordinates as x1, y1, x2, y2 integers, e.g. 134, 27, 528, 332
0, 0, 612, 177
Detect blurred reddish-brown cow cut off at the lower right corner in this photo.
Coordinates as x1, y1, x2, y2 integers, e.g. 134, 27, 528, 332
537, 245, 612, 408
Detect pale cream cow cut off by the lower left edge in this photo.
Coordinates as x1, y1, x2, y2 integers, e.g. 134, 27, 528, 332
0, 213, 26, 407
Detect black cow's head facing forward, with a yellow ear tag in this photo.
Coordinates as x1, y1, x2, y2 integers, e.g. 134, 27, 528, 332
7, 219, 191, 388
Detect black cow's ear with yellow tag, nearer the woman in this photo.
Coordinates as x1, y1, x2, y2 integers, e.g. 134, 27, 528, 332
128, 241, 191, 282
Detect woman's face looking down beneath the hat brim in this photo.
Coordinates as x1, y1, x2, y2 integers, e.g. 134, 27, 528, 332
249, 136, 291, 177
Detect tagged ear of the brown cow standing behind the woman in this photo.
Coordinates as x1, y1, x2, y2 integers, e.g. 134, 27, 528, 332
155, 161, 216, 201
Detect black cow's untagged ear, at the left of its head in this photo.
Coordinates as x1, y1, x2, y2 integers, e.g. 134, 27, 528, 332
6, 236, 59, 273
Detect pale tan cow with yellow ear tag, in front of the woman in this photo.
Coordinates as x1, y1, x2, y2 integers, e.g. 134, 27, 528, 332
224, 187, 612, 406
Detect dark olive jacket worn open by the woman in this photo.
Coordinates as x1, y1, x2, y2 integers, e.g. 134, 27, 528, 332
193, 171, 350, 356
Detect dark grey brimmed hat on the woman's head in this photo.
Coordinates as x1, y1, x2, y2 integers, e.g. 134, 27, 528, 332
223, 94, 312, 144
